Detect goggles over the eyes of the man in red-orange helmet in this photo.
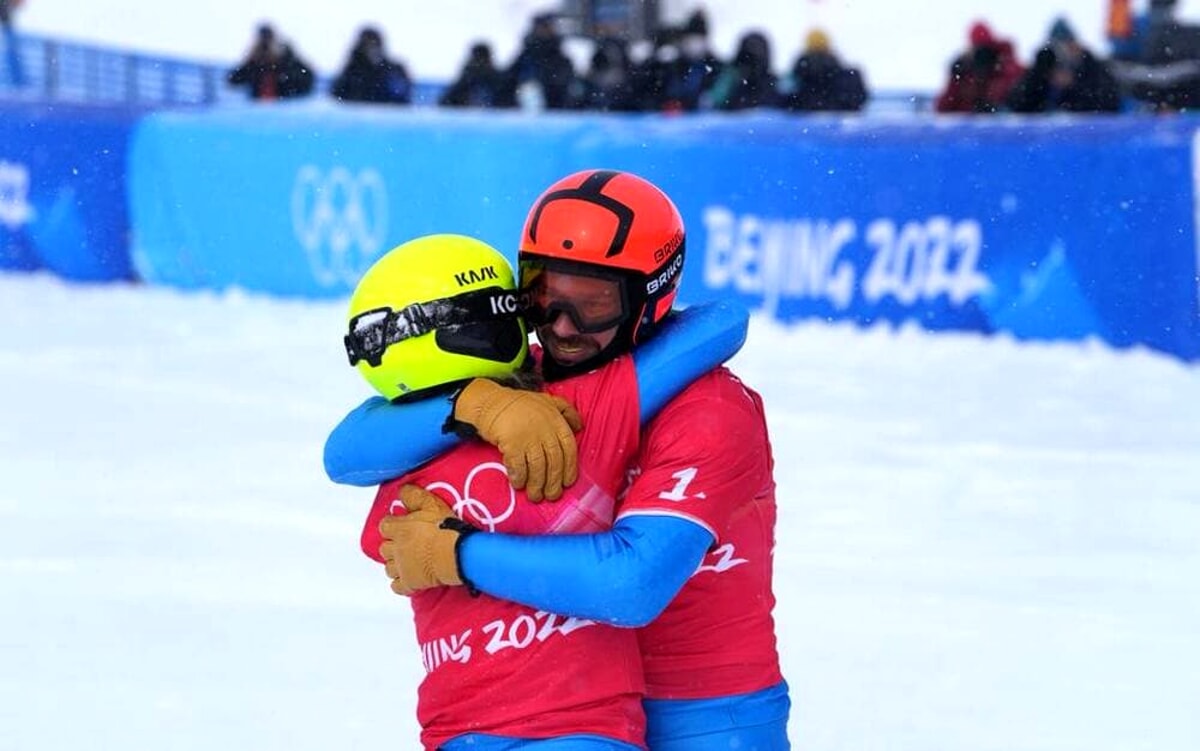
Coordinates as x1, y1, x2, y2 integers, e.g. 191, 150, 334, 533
520, 258, 629, 334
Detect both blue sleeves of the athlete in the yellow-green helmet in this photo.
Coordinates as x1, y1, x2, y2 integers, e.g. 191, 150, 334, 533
325, 301, 750, 486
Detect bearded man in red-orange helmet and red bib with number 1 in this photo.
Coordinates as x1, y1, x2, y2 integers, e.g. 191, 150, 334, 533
326, 170, 790, 751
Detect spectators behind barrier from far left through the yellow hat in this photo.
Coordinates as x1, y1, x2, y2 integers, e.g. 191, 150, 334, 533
228, 10, 869, 113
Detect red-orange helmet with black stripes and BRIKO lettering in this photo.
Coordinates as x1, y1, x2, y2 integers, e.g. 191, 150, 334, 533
517, 169, 684, 370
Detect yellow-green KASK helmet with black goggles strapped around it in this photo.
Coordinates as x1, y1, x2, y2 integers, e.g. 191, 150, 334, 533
346, 234, 528, 399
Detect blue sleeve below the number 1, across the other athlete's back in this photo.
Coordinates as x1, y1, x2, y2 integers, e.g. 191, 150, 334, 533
458, 516, 713, 627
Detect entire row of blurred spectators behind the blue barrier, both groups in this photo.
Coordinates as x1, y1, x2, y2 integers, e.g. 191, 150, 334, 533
228, 0, 1200, 114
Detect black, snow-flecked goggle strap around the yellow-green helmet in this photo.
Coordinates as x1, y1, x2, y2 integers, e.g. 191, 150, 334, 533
343, 287, 524, 367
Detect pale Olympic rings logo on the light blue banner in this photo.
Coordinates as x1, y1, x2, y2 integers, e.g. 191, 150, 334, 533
292, 164, 388, 287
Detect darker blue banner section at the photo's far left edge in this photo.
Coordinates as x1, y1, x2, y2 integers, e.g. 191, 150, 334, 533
0, 103, 140, 282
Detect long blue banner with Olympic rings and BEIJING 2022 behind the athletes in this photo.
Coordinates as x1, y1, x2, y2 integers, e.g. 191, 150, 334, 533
130, 107, 1200, 359
